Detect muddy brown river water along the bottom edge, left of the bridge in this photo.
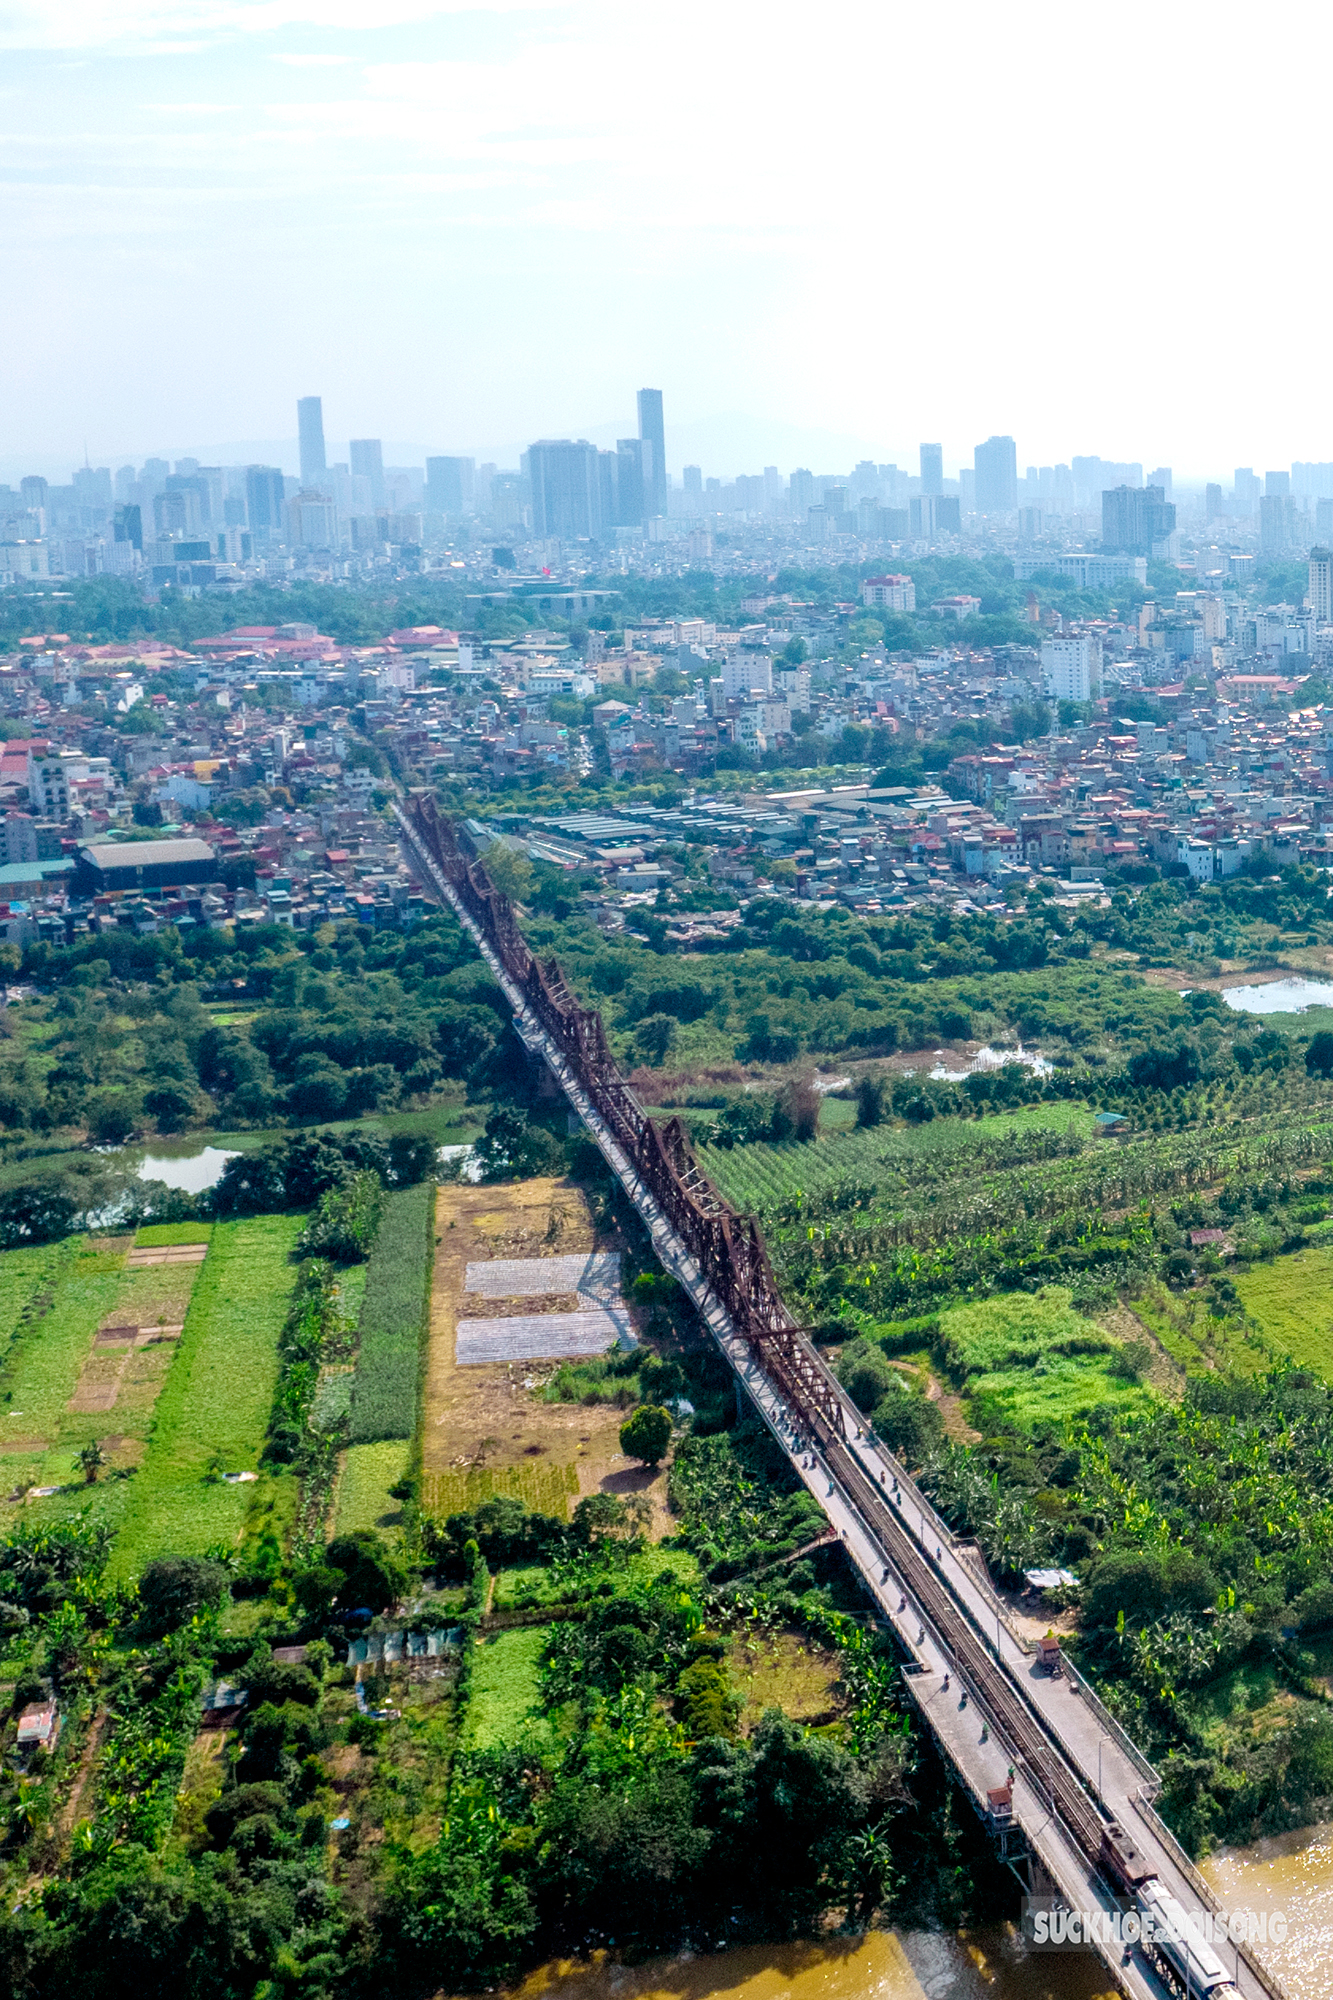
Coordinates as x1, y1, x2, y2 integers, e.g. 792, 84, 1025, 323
472, 1926, 1113, 2000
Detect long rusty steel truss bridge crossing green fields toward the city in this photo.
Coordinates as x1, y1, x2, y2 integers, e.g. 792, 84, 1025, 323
394, 794, 1285, 2000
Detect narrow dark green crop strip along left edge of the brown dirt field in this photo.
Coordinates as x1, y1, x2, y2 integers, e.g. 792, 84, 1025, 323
350, 1182, 434, 1444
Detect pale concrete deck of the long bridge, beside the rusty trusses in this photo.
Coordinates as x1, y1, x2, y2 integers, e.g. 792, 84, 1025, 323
398, 814, 1285, 2000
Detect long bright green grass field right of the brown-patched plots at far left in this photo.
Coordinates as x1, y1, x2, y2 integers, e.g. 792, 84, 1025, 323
112, 1216, 300, 1576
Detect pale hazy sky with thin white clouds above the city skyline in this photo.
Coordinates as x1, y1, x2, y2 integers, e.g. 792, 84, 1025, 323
0, 0, 1333, 478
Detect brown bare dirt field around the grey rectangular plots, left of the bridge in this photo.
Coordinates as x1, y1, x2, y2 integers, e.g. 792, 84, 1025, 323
422, 1178, 669, 1534
